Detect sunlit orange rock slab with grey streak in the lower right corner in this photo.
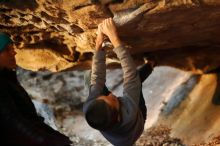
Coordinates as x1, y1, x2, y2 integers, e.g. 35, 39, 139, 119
157, 74, 220, 145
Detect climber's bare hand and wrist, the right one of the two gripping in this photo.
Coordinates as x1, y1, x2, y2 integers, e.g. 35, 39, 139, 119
101, 18, 122, 48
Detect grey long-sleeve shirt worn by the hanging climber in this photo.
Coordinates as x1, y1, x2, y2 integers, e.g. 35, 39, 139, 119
84, 46, 145, 146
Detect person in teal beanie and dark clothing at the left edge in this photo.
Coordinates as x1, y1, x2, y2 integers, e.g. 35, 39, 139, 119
0, 33, 71, 146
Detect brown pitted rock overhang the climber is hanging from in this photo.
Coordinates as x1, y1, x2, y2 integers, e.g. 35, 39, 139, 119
0, 0, 220, 73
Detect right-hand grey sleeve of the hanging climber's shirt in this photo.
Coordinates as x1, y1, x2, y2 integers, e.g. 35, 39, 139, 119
113, 45, 141, 104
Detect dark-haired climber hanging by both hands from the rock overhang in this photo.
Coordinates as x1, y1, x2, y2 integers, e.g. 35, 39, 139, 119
83, 18, 154, 146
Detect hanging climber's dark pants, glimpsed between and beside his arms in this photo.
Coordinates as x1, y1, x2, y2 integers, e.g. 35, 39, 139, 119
96, 64, 153, 120
